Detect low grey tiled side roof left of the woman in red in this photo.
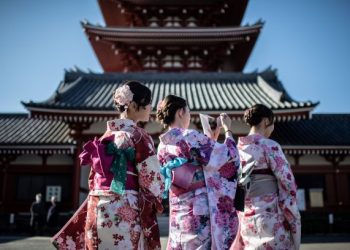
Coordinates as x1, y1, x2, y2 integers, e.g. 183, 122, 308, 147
0, 113, 75, 154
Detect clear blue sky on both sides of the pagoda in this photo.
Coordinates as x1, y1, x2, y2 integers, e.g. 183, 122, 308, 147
0, 0, 350, 113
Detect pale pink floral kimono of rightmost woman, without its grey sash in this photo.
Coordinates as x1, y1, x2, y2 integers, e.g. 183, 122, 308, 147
231, 134, 301, 249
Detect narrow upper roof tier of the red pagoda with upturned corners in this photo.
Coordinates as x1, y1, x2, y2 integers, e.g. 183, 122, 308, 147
82, 22, 263, 45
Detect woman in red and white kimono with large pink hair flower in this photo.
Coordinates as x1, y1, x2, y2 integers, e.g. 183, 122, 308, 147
54, 81, 164, 250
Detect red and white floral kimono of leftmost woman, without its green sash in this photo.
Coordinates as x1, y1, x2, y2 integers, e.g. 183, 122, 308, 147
53, 119, 164, 250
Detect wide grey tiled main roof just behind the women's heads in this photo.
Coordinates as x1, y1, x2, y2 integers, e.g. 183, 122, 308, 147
23, 70, 317, 121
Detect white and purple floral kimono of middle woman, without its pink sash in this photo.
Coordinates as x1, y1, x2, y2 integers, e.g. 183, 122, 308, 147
158, 128, 239, 249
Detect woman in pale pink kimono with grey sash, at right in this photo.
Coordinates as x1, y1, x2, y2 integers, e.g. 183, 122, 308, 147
231, 104, 301, 249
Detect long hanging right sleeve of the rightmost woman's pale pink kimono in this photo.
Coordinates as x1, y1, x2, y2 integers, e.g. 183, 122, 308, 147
267, 142, 301, 249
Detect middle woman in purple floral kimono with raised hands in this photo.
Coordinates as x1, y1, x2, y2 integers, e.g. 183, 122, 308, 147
157, 95, 239, 250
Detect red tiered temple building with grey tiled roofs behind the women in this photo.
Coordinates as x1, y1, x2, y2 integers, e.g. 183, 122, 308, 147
0, 0, 350, 232
